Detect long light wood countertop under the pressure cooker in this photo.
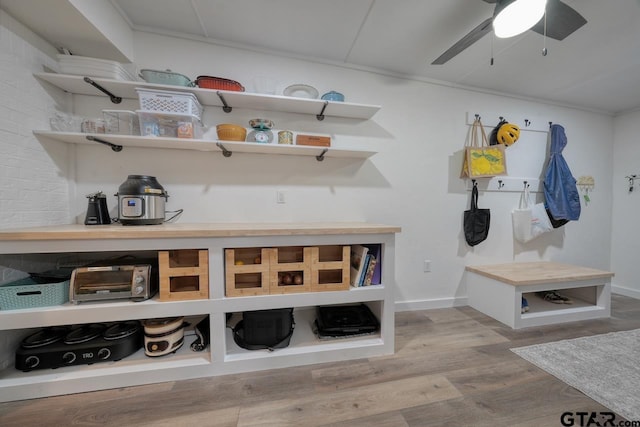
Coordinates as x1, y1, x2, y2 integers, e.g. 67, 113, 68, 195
0, 222, 400, 241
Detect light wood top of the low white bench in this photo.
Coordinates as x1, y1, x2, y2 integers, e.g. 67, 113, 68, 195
466, 261, 614, 286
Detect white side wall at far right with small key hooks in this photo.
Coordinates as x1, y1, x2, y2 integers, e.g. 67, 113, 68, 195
611, 111, 640, 298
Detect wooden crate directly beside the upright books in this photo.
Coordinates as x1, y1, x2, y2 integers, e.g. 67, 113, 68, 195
310, 245, 351, 292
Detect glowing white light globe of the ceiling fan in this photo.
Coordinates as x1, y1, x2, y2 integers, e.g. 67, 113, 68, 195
493, 0, 547, 38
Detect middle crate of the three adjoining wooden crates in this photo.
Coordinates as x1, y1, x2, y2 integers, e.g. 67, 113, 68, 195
269, 246, 311, 294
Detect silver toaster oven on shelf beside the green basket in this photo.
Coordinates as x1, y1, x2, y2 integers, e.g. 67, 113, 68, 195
69, 264, 158, 304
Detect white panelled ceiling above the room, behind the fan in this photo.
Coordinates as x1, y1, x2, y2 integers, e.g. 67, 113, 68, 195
3, 0, 640, 114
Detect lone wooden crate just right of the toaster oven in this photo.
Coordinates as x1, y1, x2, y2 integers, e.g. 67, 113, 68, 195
158, 249, 209, 301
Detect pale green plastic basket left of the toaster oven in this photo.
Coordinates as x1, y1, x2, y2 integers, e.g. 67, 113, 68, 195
0, 277, 69, 310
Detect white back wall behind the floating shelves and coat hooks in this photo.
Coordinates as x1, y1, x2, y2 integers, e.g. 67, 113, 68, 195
65, 33, 613, 309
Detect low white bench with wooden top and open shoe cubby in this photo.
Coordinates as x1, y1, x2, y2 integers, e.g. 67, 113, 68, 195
466, 261, 614, 329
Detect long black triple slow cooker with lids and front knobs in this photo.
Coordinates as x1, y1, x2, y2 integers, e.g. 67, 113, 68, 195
15, 320, 143, 372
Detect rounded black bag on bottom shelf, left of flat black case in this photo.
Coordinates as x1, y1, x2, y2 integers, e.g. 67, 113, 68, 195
233, 308, 295, 351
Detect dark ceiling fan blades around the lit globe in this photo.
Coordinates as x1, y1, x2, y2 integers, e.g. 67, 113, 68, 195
431, 0, 587, 65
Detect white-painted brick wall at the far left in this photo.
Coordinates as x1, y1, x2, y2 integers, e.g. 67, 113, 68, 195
0, 11, 70, 232
